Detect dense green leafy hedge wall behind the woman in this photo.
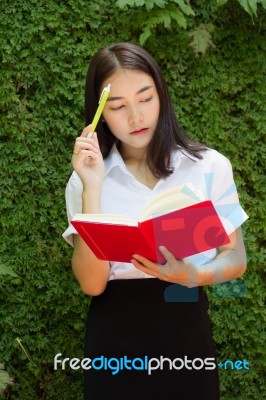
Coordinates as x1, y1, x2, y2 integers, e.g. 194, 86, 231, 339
0, 0, 266, 400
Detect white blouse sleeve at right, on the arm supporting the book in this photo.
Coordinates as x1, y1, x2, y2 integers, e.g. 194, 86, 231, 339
205, 152, 248, 235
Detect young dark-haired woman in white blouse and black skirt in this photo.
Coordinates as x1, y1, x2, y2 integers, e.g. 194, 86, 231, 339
64, 43, 247, 400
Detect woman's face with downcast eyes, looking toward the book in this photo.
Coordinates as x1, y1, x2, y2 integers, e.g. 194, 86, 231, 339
102, 69, 160, 156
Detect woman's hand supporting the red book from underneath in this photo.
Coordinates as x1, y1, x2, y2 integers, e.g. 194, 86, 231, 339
131, 246, 202, 288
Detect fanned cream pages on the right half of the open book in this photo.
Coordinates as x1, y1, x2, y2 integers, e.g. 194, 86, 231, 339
140, 183, 206, 222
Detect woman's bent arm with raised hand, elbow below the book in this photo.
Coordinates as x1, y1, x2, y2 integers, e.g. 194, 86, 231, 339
72, 125, 110, 296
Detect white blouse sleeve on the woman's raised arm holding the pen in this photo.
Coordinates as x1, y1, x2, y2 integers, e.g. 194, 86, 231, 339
62, 171, 83, 246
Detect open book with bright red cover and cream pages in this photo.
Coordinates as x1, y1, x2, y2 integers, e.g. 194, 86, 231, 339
71, 183, 230, 263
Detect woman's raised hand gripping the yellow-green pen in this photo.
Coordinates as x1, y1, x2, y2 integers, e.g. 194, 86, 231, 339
71, 125, 104, 189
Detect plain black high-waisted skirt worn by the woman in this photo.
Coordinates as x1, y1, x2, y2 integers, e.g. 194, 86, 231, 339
84, 278, 219, 400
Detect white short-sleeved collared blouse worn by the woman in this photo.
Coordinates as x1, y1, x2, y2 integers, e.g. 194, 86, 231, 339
63, 145, 248, 280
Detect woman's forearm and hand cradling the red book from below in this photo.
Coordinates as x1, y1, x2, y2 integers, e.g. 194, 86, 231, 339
132, 228, 246, 288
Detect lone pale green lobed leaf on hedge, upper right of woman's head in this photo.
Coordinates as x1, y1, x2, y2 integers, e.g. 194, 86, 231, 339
189, 24, 214, 55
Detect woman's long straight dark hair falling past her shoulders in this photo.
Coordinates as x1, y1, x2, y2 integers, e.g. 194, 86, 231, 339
85, 42, 206, 178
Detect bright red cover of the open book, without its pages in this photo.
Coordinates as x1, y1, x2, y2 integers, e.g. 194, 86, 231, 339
71, 200, 230, 264
